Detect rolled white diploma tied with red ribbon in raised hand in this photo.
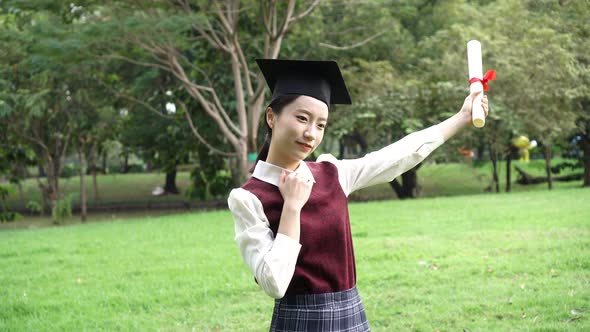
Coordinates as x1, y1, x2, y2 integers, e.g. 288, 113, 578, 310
467, 40, 486, 128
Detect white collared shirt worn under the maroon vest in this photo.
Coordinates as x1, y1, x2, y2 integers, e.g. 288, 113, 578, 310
228, 126, 444, 299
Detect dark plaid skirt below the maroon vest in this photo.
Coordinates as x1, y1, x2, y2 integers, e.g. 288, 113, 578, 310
270, 287, 370, 332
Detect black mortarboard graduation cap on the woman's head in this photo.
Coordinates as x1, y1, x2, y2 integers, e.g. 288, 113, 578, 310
256, 59, 352, 105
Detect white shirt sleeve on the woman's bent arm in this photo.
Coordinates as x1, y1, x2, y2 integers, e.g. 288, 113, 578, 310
227, 188, 301, 299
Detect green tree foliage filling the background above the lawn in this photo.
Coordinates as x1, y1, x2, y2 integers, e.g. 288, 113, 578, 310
0, 0, 590, 196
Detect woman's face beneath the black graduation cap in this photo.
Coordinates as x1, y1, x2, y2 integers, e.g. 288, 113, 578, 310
266, 96, 328, 170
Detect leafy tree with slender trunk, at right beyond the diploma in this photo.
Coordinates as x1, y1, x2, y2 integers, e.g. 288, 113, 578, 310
494, 1, 578, 189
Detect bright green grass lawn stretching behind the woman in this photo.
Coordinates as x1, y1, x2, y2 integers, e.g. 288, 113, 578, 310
0, 189, 590, 331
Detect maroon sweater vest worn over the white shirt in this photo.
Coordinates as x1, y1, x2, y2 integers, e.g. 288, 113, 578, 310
242, 162, 356, 295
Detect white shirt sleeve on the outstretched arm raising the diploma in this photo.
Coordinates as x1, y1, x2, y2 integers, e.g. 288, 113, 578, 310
317, 125, 444, 196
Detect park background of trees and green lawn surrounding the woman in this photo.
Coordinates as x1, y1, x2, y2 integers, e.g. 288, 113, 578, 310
0, 0, 590, 331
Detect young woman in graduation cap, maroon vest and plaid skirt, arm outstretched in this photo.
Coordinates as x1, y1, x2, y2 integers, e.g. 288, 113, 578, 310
228, 60, 488, 331
